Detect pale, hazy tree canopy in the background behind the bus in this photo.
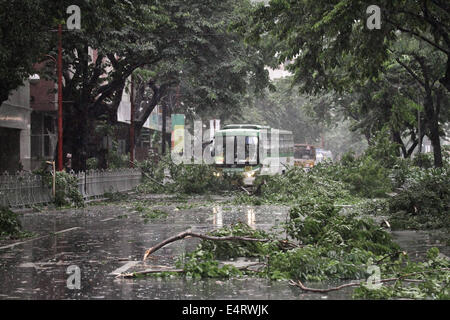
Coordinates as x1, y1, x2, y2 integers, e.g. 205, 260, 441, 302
234, 77, 367, 159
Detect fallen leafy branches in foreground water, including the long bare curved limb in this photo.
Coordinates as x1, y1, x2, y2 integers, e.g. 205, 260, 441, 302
135, 201, 449, 298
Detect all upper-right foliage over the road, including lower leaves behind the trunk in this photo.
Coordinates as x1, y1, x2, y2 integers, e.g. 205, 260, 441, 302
248, 0, 450, 166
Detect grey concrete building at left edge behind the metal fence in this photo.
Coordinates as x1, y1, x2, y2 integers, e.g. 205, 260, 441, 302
0, 64, 57, 173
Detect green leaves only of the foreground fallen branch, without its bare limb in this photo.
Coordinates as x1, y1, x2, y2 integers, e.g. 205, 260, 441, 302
163, 210, 398, 280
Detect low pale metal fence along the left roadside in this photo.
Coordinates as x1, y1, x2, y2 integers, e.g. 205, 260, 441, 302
0, 168, 142, 207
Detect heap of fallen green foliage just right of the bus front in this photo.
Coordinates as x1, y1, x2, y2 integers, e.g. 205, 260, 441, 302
235, 153, 392, 205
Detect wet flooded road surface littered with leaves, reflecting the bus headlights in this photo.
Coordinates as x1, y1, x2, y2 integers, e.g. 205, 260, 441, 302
0, 192, 449, 300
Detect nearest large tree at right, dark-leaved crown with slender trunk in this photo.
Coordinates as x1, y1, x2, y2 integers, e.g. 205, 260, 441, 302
253, 0, 450, 166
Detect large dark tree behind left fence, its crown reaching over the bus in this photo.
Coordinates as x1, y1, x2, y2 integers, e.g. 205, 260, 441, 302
38, 0, 265, 169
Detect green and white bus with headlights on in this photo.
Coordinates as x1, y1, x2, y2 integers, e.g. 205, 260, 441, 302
214, 124, 294, 185
